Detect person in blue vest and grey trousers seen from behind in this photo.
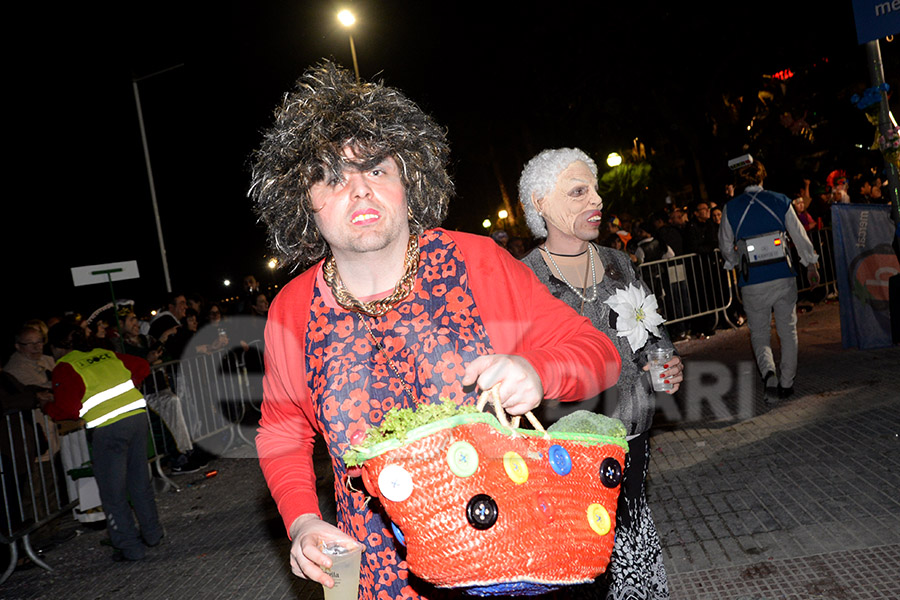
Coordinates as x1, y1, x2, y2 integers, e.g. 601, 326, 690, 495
719, 157, 819, 404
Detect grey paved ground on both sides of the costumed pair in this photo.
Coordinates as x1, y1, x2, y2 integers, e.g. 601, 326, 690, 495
0, 303, 900, 600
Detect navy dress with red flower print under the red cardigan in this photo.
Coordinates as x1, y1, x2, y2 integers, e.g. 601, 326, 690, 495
306, 231, 492, 600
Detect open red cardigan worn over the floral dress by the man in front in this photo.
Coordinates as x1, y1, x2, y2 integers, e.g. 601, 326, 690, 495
256, 230, 621, 529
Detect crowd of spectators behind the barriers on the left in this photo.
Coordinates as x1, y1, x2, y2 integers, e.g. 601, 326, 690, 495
0, 276, 269, 486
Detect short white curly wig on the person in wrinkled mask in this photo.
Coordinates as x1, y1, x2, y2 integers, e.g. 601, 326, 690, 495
519, 148, 597, 238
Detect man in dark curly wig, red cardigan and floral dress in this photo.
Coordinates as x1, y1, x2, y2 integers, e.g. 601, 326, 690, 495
250, 62, 620, 598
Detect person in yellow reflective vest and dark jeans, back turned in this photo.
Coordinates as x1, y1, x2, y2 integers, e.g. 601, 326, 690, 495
44, 323, 163, 561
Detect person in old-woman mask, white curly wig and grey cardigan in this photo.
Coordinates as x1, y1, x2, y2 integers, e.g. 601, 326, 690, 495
519, 148, 683, 600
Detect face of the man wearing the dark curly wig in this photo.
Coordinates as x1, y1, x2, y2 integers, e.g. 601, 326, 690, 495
309, 147, 409, 260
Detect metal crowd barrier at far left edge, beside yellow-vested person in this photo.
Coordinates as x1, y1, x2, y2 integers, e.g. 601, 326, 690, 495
0, 410, 78, 584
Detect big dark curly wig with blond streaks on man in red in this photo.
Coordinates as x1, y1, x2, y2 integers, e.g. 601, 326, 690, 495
248, 61, 453, 270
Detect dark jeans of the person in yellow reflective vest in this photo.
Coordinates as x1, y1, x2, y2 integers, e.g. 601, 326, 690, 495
92, 413, 163, 560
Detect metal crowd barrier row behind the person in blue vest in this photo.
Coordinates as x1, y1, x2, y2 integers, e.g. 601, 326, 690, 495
640, 228, 837, 328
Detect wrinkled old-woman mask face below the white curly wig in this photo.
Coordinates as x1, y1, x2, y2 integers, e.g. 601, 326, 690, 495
533, 160, 603, 241
